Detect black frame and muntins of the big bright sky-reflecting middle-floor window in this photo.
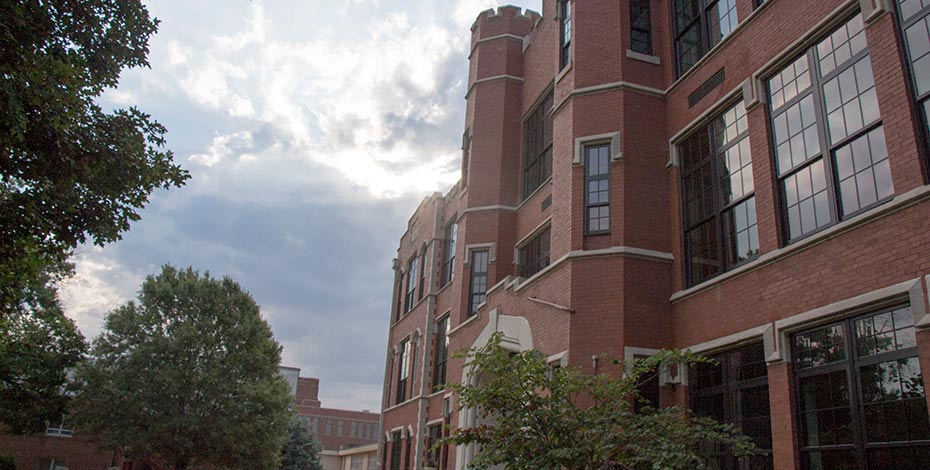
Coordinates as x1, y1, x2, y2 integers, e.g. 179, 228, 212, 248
765, 12, 895, 246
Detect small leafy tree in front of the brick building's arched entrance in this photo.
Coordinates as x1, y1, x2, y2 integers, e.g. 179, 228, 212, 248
445, 335, 756, 470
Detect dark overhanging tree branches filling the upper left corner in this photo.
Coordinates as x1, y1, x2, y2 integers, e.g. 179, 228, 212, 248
0, 0, 189, 313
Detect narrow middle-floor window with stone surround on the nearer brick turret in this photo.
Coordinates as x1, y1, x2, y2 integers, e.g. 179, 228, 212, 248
584, 143, 610, 235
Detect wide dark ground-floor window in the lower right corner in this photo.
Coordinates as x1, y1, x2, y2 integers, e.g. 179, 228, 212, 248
792, 306, 930, 469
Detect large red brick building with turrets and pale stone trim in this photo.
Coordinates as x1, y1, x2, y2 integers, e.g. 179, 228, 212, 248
380, 0, 930, 470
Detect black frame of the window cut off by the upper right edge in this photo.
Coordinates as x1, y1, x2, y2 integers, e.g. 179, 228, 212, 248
894, 0, 930, 182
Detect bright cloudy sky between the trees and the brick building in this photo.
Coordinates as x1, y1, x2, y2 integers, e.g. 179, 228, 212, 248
56, 0, 540, 410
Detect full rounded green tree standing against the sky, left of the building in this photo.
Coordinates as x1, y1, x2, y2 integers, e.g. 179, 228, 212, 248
72, 266, 292, 469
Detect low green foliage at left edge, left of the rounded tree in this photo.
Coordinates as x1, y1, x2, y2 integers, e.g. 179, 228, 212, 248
0, 266, 85, 434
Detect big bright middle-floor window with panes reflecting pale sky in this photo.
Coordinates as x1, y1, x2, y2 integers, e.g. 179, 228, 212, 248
768, 14, 894, 241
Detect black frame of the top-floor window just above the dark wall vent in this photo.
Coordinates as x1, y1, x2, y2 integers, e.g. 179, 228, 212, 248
670, 0, 739, 77
